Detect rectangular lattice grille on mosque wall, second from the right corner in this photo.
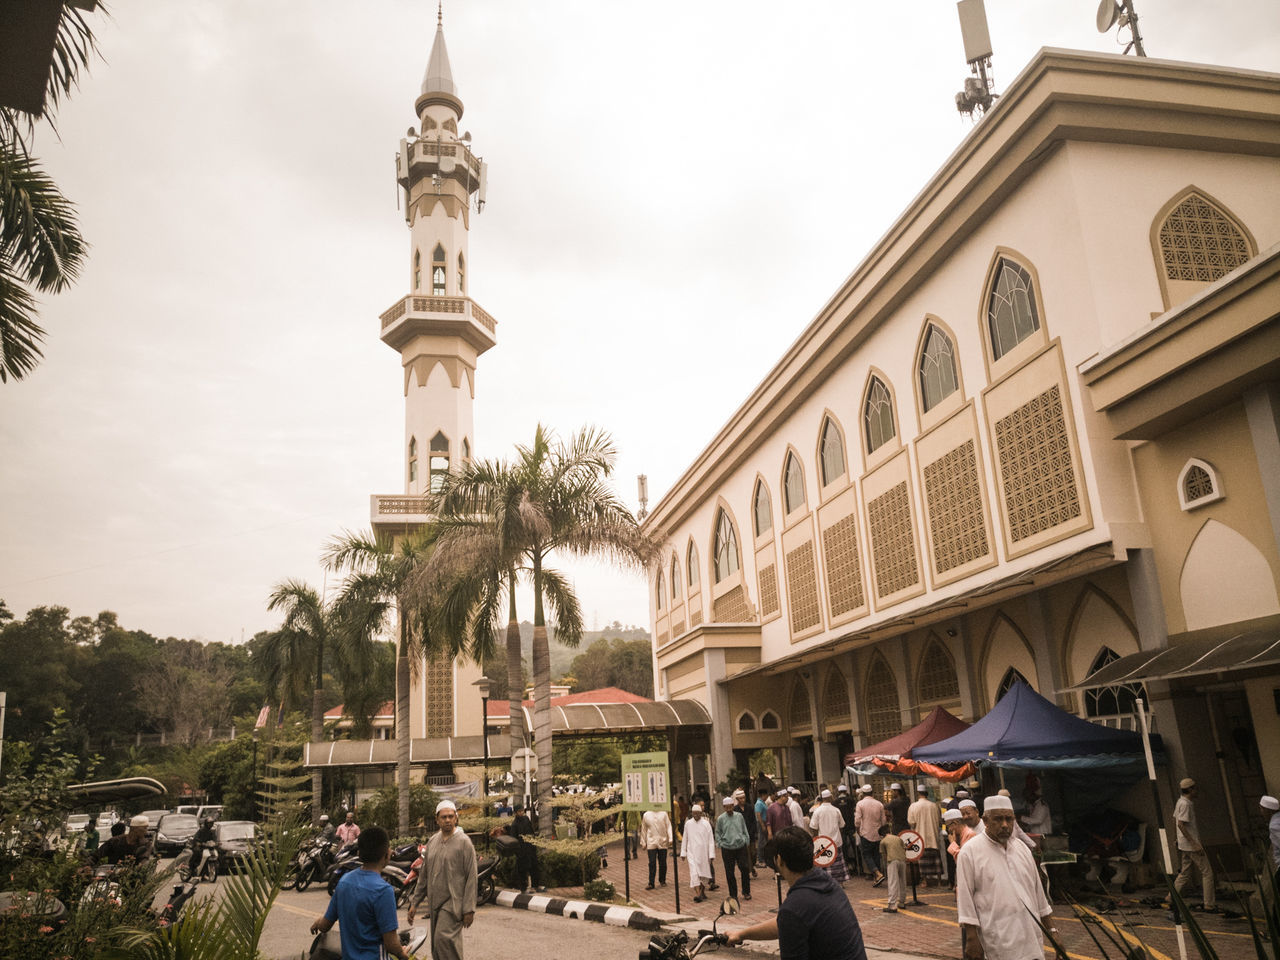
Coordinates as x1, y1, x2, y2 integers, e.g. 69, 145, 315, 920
924, 440, 991, 573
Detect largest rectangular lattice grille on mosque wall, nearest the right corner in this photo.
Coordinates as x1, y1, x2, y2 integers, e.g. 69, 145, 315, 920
996, 384, 1080, 543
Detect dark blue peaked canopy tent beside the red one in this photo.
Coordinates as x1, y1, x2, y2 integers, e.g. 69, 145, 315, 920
911, 681, 1164, 769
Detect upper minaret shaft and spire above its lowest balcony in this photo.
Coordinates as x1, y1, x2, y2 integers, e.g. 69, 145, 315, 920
375, 9, 497, 504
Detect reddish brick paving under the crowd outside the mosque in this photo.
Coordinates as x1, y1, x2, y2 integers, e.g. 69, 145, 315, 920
524, 841, 1256, 960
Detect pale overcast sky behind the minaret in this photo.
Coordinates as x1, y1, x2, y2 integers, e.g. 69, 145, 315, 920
0, 0, 1280, 641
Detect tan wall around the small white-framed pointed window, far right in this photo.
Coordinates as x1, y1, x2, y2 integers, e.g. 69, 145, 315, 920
1133, 403, 1280, 634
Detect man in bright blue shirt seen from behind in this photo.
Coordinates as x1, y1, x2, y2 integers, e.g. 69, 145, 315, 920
311, 827, 408, 960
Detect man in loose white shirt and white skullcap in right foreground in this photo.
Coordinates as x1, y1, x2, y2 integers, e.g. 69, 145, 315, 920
956, 795, 1055, 960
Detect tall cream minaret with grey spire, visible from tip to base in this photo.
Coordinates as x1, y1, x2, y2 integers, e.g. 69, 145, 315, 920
372, 9, 497, 742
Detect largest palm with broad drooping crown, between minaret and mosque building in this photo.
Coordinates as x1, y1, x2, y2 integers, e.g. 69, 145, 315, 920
430, 424, 652, 833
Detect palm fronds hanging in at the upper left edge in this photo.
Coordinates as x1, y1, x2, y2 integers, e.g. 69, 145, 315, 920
0, 0, 95, 383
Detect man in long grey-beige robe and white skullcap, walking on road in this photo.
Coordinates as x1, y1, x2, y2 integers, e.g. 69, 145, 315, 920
408, 800, 476, 960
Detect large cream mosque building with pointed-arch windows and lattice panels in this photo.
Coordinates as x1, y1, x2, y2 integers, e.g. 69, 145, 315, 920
645, 49, 1280, 870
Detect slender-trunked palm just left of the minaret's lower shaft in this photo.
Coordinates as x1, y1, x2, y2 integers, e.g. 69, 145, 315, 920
324, 527, 484, 836
